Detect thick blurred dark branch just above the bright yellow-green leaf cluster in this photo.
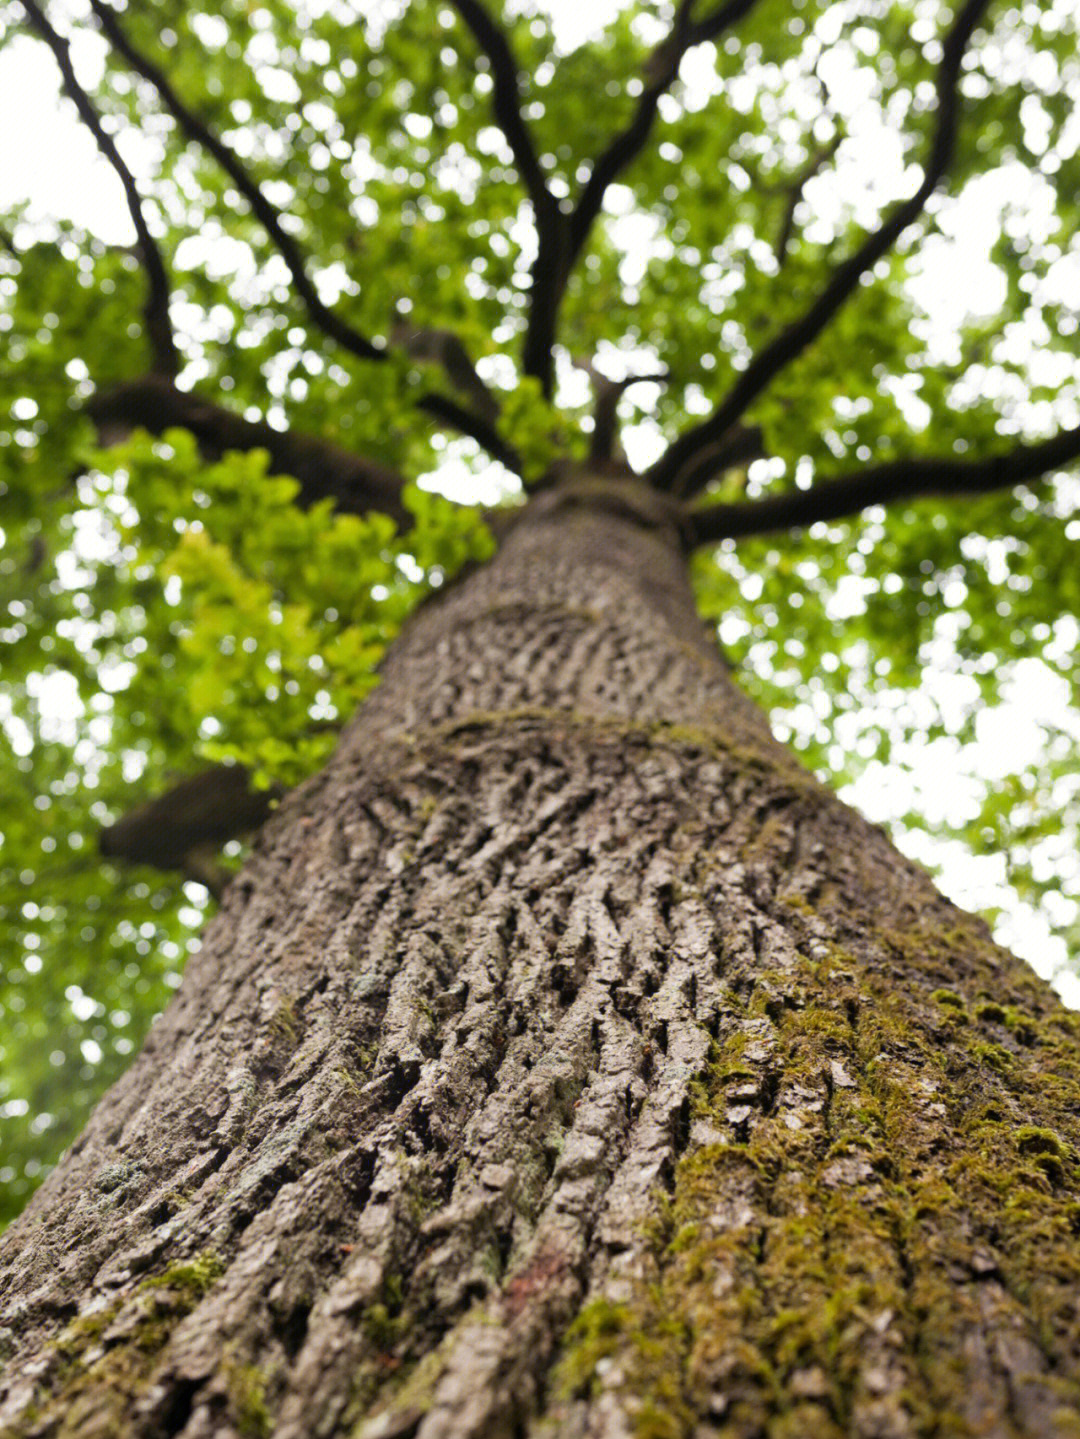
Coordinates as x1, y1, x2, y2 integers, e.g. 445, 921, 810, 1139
86, 376, 413, 525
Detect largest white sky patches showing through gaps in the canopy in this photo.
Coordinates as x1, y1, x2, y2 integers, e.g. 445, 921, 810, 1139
0, 0, 1080, 1007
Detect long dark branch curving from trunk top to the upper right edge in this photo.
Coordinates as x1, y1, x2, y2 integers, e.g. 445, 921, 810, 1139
649, 0, 989, 488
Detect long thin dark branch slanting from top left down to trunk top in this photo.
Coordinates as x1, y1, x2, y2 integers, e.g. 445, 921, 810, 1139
91, 0, 519, 469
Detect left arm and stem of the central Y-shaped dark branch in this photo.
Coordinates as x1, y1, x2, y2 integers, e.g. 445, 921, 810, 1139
453, 0, 567, 399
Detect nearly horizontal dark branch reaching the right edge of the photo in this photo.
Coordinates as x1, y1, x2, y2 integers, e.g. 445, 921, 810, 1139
686, 426, 1080, 545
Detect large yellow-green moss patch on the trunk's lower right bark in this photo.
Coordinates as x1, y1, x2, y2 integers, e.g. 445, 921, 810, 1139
558, 912, 1080, 1439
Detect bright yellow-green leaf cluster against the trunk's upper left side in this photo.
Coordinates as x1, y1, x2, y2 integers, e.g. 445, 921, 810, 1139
83, 430, 434, 784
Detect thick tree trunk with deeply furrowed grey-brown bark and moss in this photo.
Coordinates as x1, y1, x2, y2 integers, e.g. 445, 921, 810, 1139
0, 496, 1080, 1439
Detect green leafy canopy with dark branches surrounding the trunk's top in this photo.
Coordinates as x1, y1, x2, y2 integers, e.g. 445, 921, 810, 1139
0, 0, 1080, 1220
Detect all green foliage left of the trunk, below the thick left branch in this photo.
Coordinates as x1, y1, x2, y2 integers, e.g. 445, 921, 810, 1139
0, 427, 492, 1222
